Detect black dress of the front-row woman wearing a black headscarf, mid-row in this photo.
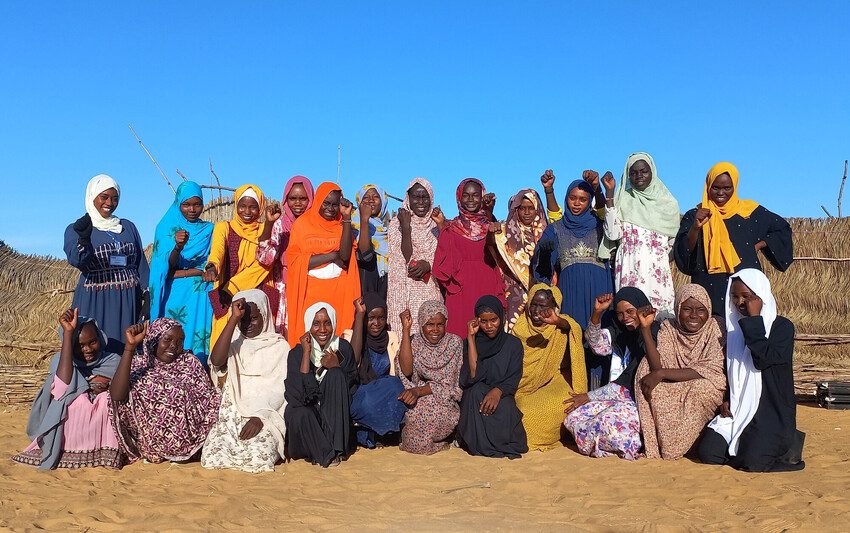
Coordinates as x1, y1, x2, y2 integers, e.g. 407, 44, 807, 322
457, 332, 528, 459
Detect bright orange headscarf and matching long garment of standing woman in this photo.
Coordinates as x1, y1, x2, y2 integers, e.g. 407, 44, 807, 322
286, 182, 360, 346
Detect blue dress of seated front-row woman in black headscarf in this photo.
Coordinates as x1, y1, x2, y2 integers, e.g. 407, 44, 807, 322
351, 347, 407, 448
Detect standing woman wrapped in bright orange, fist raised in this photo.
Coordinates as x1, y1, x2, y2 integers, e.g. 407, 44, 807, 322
286, 182, 360, 346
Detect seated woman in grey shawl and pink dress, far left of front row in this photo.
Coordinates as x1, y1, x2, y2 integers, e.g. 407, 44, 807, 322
12, 307, 122, 470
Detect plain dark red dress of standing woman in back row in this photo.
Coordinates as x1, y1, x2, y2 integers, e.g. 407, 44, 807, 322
431, 229, 505, 339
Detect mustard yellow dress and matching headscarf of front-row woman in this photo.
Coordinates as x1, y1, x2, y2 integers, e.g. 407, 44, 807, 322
513, 283, 587, 451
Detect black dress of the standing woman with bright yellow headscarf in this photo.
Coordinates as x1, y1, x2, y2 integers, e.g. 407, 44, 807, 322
673, 206, 794, 317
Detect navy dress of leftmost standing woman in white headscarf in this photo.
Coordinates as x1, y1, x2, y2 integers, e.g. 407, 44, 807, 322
65, 218, 149, 354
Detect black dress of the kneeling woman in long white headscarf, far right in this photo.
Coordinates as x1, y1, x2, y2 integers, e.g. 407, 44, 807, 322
699, 316, 805, 472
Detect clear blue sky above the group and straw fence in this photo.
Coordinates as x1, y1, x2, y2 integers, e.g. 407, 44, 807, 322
0, 1, 850, 255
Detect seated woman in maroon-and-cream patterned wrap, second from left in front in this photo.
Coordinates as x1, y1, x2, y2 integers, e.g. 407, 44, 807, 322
109, 318, 221, 463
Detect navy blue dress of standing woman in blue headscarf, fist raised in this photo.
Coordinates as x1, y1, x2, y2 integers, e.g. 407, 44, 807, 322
531, 219, 614, 331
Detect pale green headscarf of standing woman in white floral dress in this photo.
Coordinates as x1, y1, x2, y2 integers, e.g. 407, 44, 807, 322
599, 152, 682, 259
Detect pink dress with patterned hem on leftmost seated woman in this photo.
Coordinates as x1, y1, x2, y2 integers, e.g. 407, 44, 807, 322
12, 376, 125, 468
